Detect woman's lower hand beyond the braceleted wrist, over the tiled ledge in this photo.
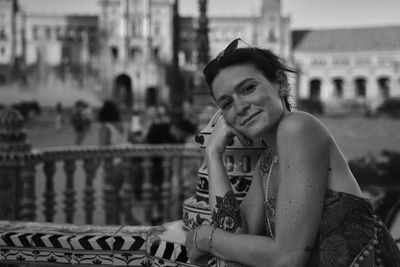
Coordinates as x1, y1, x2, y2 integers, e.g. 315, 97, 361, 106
185, 225, 212, 266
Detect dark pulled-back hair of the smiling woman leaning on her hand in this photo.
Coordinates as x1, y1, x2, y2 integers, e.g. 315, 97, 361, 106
203, 46, 297, 110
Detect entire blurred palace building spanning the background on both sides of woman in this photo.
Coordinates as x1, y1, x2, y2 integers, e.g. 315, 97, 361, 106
0, 0, 400, 113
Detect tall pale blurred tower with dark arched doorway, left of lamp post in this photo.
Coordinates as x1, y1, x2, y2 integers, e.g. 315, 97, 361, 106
99, 0, 172, 110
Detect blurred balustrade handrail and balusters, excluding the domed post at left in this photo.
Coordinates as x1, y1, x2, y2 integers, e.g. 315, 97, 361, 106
34, 145, 201, 224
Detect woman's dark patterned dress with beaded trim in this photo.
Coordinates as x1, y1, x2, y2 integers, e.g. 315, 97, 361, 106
266, 189, 400, 267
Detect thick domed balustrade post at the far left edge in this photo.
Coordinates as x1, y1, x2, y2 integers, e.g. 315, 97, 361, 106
0, 108, 35, 220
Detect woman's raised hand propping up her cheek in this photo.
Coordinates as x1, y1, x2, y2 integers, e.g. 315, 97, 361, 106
206, 112, 252, 154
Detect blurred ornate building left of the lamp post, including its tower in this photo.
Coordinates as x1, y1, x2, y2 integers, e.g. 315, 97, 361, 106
0, 0, 172, 112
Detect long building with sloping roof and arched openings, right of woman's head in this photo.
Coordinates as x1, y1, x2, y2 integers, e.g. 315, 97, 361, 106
292, 26, 400, 109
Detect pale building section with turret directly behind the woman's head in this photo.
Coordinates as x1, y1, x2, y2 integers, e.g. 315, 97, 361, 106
181, 0, 291, 63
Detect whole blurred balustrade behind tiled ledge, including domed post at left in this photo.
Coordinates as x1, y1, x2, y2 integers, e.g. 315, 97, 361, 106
0, 109, 202, 225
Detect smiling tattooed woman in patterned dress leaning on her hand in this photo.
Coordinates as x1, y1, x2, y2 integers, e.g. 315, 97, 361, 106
186, 39, 400, 267
